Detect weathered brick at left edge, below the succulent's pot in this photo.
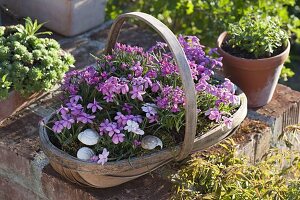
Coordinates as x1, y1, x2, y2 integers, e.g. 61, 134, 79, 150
0, 112, 40, 180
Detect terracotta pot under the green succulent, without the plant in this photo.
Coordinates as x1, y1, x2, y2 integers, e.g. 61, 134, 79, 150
0, 91, 43, 123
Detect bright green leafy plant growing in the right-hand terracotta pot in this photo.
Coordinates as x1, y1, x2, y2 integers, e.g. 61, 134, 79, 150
222, 15, 288, 59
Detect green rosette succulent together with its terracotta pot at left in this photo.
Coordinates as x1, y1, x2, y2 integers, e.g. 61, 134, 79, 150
0, 18, 74, 121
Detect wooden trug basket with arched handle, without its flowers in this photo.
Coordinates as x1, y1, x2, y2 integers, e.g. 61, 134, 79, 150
40, 12, 247, 188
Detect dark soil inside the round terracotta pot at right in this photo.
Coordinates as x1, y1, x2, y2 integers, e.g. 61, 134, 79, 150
221, 37, 286, 59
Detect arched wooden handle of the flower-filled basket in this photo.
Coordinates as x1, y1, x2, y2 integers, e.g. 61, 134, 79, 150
105, 12, 197, 160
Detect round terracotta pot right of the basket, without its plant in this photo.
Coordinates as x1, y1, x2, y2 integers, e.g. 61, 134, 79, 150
217, 32, 290, 108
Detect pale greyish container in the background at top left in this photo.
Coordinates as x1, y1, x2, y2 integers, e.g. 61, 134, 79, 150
0, 0, 106, 36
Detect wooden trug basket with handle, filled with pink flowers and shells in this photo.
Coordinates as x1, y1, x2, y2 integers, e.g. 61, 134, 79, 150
40, 12, 247, 188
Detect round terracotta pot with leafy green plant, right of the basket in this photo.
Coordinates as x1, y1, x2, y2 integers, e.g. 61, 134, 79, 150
217, 15, 290, 107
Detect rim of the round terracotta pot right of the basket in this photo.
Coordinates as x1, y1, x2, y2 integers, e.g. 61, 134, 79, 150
217, 31, 291, 62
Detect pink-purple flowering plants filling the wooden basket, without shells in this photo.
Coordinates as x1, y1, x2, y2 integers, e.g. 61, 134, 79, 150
47, 36, 239, 164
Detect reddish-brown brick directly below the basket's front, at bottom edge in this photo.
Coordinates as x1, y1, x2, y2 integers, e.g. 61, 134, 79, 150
42, 166, 171, 200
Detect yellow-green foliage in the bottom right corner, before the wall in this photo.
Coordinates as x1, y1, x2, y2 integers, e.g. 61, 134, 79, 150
173, 140, 300, 200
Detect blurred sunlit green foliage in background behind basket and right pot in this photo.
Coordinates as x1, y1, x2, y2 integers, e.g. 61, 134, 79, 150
106, 0, 300, 87
